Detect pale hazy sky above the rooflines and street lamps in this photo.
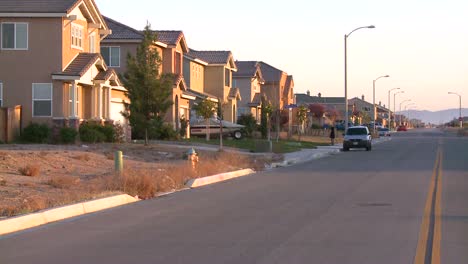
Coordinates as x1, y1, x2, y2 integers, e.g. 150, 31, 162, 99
95, 0, 468, 111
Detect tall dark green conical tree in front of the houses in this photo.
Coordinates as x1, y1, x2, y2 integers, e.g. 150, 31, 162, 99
122, 23, 174, 145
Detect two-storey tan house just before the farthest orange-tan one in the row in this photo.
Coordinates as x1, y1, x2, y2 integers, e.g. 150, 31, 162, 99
233, 61, 265, 123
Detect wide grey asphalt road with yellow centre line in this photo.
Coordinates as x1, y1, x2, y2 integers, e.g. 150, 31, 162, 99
0, 130, 468, 264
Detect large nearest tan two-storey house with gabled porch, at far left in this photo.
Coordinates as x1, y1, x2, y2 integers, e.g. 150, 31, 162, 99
0, 0, 125, 132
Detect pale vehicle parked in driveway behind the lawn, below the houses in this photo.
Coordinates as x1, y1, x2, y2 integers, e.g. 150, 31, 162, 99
190, 118, 245, 139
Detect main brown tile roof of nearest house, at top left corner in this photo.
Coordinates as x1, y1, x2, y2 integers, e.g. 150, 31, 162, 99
0, 0, 79, 13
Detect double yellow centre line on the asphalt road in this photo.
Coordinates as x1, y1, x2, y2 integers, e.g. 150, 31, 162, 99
413, 145, 443, 264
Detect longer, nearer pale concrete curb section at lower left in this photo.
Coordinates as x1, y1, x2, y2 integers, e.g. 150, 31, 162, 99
0, 194, 139, 235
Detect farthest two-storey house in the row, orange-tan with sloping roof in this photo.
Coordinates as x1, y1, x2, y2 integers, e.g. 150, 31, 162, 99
258, 61, 294, 110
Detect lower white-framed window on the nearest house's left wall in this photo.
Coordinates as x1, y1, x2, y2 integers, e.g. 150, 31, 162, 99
33, 83, 52, 117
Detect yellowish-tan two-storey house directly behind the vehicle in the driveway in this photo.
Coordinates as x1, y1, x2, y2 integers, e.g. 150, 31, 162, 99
188, 49, 241, 123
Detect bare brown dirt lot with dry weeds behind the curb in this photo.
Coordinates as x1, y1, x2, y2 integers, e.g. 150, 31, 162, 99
0, 144, 278, 217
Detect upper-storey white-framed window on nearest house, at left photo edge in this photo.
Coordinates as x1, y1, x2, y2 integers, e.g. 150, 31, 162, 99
2, 23, 28, 50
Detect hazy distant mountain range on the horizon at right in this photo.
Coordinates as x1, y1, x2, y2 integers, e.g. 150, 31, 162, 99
397, 108, 468, 124
